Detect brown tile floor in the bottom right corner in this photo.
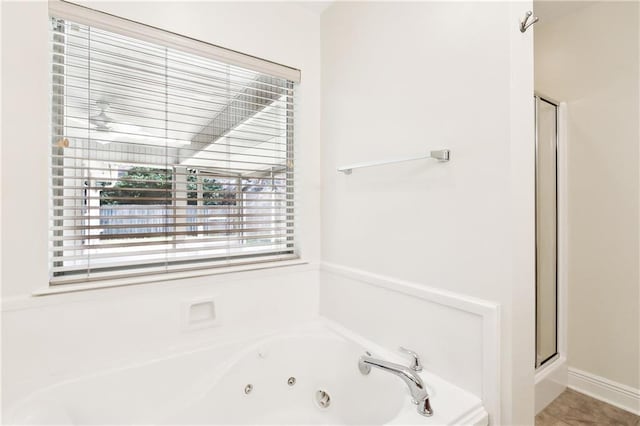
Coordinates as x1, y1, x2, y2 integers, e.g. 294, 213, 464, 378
536, 389, 640, 426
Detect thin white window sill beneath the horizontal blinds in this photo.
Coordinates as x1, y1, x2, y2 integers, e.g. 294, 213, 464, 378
31, 259, 309, 296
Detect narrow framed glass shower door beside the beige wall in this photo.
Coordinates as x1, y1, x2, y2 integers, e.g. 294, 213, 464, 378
535, 96, 558, 368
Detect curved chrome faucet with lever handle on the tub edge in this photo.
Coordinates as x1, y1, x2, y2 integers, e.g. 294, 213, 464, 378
358, 347, 433, 417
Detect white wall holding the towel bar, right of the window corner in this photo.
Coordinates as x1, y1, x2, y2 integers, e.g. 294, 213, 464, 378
321, 2, 534, 424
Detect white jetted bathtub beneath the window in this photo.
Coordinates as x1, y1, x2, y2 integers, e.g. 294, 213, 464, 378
5, 320, 488, 426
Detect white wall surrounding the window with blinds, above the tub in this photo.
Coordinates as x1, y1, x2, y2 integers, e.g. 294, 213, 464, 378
0, 1, 320, 412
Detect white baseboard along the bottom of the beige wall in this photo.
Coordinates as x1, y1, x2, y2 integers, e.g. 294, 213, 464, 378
569, 368, 640, 415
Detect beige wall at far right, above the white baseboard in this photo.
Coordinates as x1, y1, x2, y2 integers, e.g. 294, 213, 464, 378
535, 2, 640, 389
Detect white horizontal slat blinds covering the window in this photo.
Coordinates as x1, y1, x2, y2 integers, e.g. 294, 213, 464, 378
51, 18, 295, 284
